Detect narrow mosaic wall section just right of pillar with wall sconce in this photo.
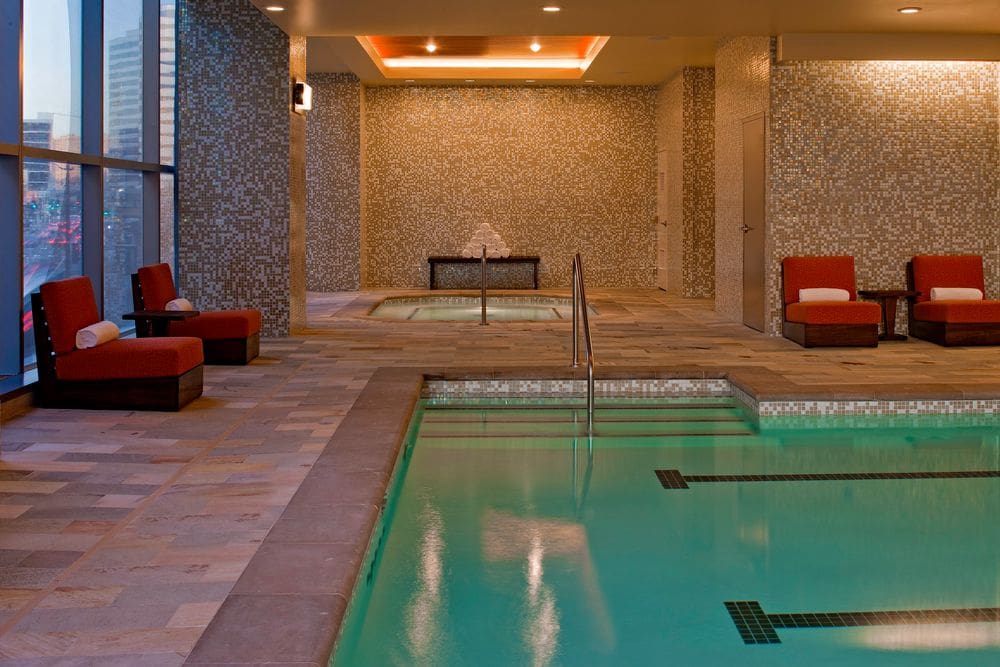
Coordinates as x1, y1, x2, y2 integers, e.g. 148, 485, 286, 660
306, 73, 361, 292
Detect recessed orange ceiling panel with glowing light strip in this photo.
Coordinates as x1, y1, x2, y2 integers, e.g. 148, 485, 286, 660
357, 35, 608, 80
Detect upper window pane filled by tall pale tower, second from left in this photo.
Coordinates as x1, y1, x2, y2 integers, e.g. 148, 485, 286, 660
104, 0, 142, 160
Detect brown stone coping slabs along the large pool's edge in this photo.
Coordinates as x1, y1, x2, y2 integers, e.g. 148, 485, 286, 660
184, 366, 1000, 667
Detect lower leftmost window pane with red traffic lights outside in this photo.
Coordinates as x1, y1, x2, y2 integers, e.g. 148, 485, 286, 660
22, 160, 83, 367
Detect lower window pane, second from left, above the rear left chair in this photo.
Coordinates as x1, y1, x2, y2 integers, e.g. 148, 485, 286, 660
104, 169, 142, 328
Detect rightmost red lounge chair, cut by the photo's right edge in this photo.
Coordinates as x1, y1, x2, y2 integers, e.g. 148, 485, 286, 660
906, 255, 1000, 345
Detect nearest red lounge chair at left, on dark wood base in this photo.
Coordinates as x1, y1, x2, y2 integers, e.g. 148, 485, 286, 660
31, 276, 203, 410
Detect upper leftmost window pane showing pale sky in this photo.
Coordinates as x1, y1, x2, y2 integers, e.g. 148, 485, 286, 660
23, 0, 83, 153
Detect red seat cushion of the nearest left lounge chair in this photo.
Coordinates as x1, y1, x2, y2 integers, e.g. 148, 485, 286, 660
56, 338, 205, 380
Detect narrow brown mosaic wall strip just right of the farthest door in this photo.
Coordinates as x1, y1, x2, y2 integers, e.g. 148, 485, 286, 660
683, 67, 715, 299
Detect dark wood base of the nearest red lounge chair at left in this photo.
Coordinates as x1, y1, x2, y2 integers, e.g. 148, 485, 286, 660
35, 364, 204, 411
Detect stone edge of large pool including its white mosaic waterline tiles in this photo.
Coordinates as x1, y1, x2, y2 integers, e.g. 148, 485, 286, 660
187, 367, 1000, 665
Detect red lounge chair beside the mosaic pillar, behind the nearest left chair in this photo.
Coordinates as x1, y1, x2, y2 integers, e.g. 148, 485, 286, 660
132, 264, 260, 364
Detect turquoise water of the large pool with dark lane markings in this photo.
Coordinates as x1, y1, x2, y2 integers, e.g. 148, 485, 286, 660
332, 399, 1000, 667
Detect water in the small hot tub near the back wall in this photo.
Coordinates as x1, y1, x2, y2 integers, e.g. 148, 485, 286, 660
371, 296, 596, 322
